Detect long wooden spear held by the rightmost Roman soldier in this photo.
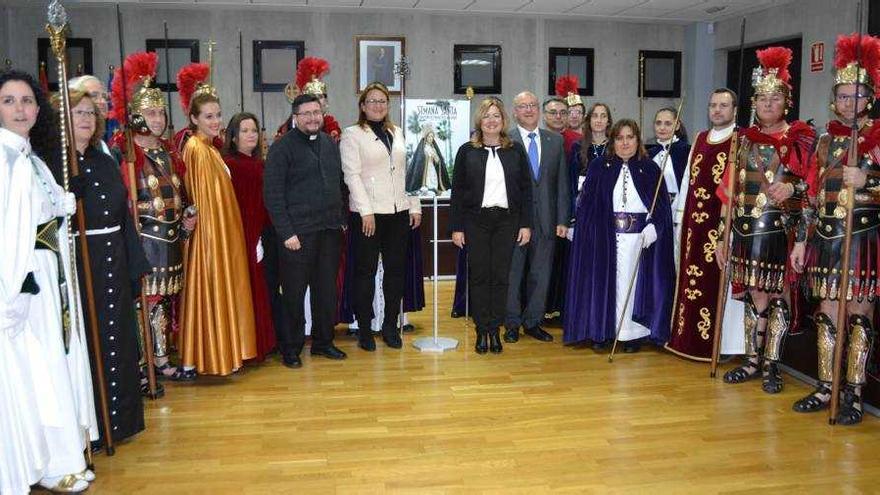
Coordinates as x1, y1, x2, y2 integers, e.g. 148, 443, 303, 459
828, 0, 862, 426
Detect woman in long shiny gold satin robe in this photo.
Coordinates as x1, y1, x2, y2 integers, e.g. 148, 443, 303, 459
177, 64, 256, 380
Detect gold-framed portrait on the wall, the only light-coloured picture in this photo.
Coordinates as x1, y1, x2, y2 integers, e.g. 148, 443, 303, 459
354, 36, 406, 95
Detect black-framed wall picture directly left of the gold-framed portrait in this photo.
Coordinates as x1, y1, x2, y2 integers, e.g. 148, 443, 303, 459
254, 40, 306, 93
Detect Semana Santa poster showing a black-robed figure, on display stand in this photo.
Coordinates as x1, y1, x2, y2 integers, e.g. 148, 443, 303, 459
404, 98, 471, 197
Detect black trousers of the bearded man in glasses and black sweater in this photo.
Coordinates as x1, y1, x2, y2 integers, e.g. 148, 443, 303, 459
275, 229, 342, 355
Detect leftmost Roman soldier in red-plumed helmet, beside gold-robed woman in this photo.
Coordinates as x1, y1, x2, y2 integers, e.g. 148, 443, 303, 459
111, 52, 188, 376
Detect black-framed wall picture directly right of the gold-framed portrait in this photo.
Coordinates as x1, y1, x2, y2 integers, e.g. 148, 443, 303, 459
452, 45, 501, 95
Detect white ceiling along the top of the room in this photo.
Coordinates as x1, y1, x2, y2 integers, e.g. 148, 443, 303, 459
29, 0, 794, 23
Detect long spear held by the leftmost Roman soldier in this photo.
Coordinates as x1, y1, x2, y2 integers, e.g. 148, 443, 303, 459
116, 4, 160, 400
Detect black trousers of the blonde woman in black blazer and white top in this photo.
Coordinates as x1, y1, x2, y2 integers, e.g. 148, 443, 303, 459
465, 208, 519, 332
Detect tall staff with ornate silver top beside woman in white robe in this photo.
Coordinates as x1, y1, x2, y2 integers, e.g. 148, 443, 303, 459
46, 0, 115, 456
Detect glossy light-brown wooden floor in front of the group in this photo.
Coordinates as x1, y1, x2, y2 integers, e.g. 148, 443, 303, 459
77, 282, 880, 495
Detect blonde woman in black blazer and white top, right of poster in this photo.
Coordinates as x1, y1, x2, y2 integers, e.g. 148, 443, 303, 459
450, 98, 532, 354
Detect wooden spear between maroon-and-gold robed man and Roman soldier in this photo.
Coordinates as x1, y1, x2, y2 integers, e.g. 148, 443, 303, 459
709, 17, 746, 378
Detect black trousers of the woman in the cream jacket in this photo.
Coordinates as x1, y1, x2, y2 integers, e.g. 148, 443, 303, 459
351, 211, 409, 334
